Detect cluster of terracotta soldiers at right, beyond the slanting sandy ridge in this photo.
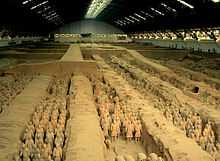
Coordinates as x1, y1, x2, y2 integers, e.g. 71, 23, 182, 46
164, 106, 217, 155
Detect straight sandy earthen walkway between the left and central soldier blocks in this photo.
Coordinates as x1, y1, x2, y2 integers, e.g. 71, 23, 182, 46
66, 75, 105, 161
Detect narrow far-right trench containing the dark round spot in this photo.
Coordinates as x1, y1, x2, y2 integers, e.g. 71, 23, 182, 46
124, 51, 220, 109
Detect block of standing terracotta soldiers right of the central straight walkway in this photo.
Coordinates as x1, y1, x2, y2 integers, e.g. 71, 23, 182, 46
94, 81, 142, 141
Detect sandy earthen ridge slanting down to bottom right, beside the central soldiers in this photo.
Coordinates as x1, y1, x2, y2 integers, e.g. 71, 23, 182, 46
93, 55, 214, 161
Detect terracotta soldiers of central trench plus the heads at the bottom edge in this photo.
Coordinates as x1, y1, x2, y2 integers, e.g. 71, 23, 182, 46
93, 77, 163, 161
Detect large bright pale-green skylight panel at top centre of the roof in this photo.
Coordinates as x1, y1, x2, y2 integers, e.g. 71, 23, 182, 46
85, 0, 112, 19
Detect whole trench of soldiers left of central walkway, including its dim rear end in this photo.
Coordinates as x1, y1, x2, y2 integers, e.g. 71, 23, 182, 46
13, 76, 70, 161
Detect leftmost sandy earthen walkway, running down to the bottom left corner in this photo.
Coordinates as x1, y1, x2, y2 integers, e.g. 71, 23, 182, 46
0, 76, 51, 161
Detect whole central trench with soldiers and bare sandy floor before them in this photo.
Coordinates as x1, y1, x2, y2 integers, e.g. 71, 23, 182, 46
91, 78, 166, 161
